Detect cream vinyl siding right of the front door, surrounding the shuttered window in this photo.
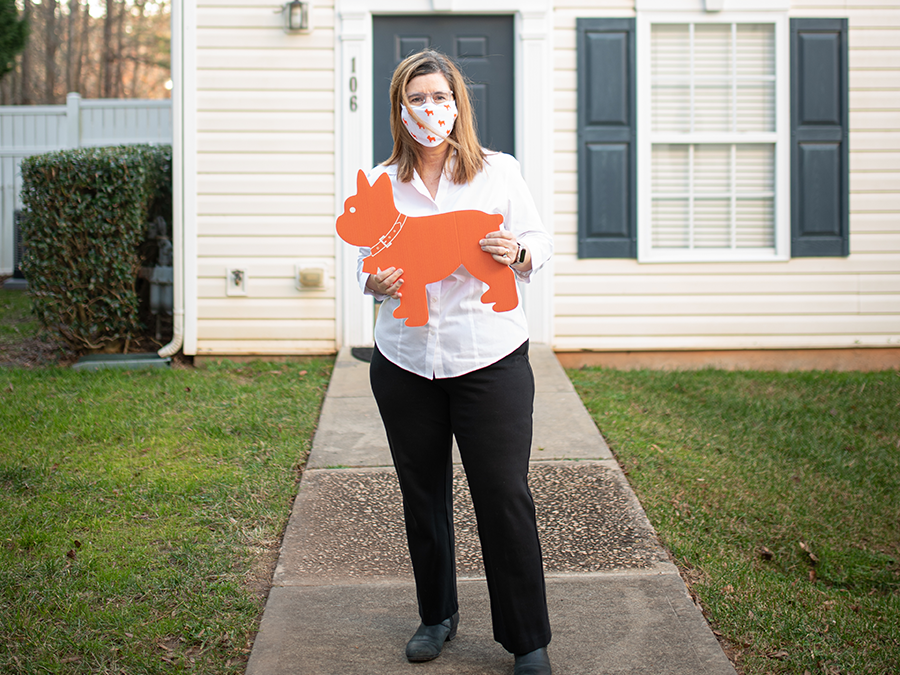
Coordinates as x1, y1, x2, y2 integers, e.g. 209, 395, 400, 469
553, 0, 900, 350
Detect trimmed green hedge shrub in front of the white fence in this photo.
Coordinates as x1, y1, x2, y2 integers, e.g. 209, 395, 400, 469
22, 145, 172, 351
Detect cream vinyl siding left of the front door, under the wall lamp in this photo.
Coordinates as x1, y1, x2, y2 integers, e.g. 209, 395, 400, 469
196, 0, 337, 355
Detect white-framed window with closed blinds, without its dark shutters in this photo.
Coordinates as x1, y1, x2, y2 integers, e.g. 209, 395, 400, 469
637, 16, 790, 262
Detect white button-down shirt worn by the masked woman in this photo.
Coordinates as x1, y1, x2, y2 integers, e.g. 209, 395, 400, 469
357, 153, 553, 379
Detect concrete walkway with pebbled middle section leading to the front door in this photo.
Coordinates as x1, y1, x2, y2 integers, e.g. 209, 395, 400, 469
247, 344, 735, 675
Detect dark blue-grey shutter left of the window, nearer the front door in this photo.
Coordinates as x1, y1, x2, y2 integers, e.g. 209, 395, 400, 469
576, 19, 637, 258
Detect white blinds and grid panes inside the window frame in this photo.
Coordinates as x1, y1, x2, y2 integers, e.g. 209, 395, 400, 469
644, 22, 777, 259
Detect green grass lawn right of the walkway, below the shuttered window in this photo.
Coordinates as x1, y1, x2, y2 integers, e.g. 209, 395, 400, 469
569, 369, 900, 675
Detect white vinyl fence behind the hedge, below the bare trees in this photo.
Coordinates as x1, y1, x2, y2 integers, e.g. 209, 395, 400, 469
0, 94, 172, 274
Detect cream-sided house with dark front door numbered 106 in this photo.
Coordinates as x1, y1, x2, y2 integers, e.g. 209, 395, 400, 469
164, 0, 900, 368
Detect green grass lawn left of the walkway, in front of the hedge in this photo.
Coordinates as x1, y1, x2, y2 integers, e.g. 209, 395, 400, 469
0, 359, 332, 674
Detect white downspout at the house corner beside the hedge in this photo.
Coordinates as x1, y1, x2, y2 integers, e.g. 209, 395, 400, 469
156, 0, 184, 358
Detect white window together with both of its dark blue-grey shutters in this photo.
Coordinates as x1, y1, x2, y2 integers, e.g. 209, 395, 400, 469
576, 15, 850, 262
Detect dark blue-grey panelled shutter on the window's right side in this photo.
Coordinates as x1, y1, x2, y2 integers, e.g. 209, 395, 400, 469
791, 19, 850, 257
